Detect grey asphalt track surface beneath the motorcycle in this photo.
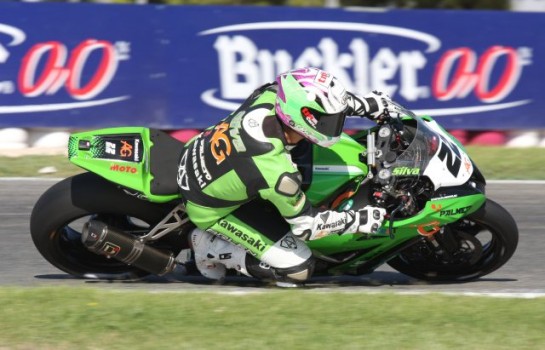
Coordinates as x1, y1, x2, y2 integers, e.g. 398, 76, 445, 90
0, 178, 545, 297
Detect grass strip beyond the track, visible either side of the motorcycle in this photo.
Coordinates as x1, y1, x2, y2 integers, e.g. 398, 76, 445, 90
0, 147, 545, 180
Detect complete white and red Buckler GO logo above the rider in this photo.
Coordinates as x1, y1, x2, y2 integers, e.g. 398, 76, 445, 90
198, 21, 533, 116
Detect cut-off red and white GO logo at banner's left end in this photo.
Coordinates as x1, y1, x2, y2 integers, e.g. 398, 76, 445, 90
0, 23, 130, 114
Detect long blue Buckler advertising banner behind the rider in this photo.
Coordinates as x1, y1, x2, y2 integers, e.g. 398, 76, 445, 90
0, 3, 545, 130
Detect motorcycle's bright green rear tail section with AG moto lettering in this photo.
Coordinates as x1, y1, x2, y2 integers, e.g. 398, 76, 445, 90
68, 127, 184, 202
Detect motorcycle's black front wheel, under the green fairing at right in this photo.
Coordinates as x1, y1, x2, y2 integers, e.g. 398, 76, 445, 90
388, 199, 518, 281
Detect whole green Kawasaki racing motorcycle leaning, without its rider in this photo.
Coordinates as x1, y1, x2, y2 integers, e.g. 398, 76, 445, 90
30, 109, 518, 282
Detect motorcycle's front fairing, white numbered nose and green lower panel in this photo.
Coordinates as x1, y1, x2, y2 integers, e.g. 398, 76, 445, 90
308, 112, 486, 273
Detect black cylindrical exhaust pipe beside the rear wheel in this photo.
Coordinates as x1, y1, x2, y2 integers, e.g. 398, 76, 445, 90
81, 220, 176, 276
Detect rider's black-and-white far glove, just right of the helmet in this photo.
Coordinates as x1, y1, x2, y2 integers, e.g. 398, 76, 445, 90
347, 91, 401, 120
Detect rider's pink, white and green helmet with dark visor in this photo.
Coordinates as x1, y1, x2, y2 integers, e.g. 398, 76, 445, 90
275, 68, 348, 147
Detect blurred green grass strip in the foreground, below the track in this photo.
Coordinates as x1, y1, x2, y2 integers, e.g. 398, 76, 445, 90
0, 287, 545, 350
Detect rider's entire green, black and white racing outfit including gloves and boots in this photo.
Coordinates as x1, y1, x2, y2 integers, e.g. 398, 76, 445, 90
177, 84, 385, 281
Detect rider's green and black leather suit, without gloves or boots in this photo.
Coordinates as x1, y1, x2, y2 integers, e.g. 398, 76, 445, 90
178, 85, 310, 257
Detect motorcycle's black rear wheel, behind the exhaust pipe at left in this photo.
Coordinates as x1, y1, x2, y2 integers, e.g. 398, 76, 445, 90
30, 173, 191, 278
